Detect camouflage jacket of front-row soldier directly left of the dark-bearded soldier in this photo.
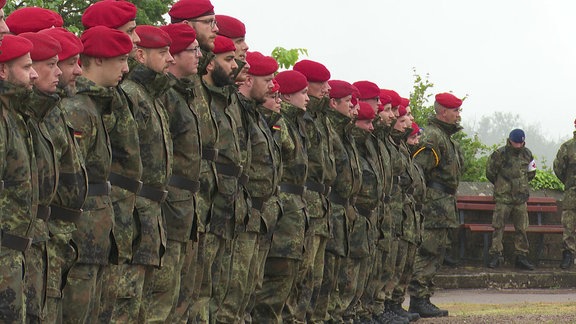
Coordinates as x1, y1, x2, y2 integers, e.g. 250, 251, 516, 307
162, 78, 202, 242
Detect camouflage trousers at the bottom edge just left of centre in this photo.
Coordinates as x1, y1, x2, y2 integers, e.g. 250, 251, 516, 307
252, 257, 301, 323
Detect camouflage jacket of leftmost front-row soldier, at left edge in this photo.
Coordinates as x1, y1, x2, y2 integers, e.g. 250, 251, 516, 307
0, 81, 38, 248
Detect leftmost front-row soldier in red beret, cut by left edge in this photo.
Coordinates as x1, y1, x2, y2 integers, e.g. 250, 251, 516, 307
0, 33, 38, 323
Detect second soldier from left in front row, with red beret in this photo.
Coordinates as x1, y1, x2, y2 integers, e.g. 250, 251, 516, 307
19, 32, 62, 323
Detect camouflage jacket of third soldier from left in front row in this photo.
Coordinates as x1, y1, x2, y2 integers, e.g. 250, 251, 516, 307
44, 91, 88, 234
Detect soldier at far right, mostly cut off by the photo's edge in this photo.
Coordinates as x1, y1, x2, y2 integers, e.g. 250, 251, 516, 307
553, 120, 576, 269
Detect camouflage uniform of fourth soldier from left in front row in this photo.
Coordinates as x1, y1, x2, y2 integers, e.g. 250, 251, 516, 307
62, 77, 115, 323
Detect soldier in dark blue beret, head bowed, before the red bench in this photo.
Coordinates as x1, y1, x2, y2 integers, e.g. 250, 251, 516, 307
486, 128, 536, 270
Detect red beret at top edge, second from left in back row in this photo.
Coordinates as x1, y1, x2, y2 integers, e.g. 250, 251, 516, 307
82, 0, 138, 29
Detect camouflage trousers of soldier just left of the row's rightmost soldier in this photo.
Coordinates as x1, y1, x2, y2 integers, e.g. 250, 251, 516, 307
390, 240, 418, 305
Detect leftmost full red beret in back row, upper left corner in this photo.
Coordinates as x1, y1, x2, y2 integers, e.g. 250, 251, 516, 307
6, 7, 64, 35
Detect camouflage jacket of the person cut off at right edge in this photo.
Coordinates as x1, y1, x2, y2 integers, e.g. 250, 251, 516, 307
553, 132, 576, 209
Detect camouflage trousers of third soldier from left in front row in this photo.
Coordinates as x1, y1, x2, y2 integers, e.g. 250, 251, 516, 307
45, 233, 78, 323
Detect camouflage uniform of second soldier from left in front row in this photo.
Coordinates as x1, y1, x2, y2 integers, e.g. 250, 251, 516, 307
22, 89, 60, 323
